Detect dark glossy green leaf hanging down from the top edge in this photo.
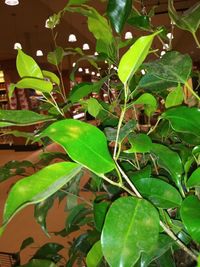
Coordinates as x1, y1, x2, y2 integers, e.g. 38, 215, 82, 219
107, 0, 132, 33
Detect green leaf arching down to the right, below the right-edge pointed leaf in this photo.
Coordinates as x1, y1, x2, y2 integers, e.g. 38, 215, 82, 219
151, 144, 183, 186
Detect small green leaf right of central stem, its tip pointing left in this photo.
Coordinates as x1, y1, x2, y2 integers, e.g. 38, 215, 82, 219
124, 133, 152, 153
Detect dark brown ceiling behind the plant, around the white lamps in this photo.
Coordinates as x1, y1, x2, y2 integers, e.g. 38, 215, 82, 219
0, 0, 200, 69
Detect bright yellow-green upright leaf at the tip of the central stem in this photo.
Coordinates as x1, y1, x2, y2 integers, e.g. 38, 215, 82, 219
118, 32, 158, 84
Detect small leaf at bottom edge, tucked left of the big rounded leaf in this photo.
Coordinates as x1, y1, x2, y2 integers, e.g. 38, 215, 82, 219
86, 241, 103, 267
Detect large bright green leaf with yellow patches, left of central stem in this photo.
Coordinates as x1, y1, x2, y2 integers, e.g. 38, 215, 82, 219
42, 119, 115, 174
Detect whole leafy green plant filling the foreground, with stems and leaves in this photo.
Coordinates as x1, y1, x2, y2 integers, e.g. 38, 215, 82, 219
0, 0, 200, 267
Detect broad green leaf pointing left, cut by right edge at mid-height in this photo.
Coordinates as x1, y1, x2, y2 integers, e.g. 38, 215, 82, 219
161, 106, 200, 137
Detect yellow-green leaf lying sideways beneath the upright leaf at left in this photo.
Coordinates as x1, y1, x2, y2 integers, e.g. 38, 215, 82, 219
9, 78, 53, 97
